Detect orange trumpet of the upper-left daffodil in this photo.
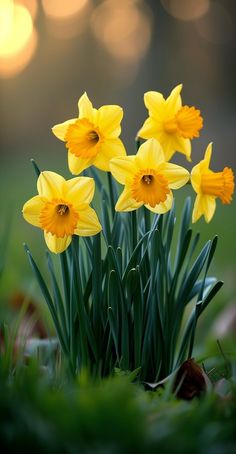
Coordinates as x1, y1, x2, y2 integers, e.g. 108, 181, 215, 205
65, 118, 101, 159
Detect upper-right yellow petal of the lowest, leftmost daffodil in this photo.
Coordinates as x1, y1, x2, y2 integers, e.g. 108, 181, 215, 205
66, 177, 95, 207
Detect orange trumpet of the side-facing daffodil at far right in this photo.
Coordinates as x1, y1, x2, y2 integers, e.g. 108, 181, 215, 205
201, 167, 234, 204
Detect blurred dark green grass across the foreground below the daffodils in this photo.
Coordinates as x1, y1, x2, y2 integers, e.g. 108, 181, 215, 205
0, 362, 236, 454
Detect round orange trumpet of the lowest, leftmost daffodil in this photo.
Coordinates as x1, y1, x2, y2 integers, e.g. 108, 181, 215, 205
39, 199, 79, 238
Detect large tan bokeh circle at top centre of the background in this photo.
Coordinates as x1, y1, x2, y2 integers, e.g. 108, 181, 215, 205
91, 0, 151, 63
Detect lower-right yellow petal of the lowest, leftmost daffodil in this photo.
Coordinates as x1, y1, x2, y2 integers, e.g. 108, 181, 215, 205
74, 206, 102, 236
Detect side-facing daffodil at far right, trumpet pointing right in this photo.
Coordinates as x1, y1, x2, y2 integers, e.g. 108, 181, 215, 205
191, 143, 234, 222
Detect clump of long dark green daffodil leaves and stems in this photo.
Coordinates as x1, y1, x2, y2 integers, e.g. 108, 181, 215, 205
25, 166, 222, 382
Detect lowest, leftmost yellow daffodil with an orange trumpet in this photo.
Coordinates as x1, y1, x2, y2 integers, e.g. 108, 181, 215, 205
23, 171, 101, 254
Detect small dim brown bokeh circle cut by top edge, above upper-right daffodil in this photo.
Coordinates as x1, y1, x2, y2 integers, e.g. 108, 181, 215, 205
161, 0, 210, 21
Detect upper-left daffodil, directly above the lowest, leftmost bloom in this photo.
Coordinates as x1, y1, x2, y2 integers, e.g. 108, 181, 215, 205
52, 93, 126, 175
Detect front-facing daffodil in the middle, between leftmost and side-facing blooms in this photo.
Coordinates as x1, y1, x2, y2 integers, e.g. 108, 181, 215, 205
110, 139, 189, 213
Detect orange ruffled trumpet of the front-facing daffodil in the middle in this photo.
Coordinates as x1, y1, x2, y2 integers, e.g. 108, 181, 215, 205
131, 169, 170, 208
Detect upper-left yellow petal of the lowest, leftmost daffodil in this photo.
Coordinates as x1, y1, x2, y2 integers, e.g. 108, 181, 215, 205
37, 170, 65, 199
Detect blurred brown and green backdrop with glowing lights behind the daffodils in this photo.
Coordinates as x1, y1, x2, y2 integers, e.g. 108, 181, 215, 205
0, 0, 236, 342
